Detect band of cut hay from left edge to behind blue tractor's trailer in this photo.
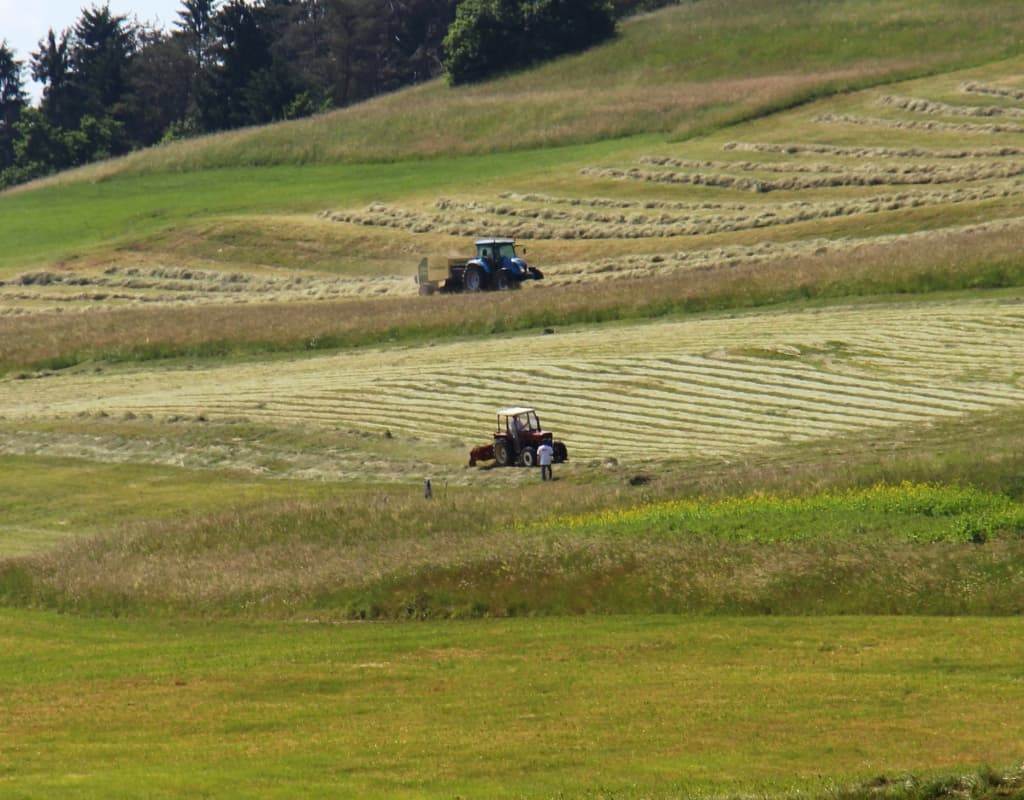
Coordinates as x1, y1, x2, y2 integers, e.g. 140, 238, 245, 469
0, 266, 415, 314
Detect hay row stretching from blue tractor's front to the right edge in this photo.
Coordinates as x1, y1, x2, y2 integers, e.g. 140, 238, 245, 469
548, 218, 1024, 284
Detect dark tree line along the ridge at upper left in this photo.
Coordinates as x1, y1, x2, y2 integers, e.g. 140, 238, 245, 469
0, 0, 673, 188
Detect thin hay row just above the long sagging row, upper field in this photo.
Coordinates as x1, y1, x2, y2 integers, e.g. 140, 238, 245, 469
639, 156, 1024, 178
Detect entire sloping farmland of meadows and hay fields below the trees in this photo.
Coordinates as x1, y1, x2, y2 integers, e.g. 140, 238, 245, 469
0, 0, 1024, 800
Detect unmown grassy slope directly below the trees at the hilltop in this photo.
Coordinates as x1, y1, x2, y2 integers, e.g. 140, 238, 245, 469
18, 0, 1024, 179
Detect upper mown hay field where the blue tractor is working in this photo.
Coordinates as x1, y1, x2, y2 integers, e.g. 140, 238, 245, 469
6, 58, 1024, 319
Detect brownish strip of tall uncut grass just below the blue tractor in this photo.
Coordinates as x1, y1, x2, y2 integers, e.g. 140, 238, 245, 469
0, 218, 1024, 372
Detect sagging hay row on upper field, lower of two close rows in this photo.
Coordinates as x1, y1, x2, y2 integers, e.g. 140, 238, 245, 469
580, 163, 1024, 194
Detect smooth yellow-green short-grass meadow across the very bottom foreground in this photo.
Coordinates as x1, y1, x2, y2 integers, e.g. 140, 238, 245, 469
0, 610, 1024, 800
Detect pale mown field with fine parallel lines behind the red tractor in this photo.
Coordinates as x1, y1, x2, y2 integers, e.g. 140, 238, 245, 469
8, 300, 1024, 459
